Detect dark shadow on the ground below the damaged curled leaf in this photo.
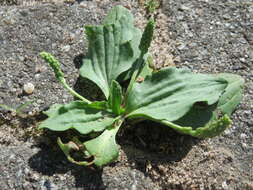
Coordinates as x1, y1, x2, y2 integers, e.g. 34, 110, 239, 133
28, 131, 105, 190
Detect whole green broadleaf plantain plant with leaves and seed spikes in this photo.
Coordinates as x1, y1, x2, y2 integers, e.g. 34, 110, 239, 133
40, 6, 244, 166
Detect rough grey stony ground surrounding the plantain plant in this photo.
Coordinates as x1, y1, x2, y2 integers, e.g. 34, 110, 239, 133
0, 0, 253, 190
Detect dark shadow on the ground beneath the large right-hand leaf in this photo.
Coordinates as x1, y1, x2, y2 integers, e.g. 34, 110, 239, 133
117, 121, 201, 174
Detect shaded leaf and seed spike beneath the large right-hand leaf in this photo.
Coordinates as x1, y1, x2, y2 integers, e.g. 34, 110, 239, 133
162, 74, 244, 138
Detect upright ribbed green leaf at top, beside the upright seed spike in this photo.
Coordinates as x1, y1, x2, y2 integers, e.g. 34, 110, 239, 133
80, 7, 141, 99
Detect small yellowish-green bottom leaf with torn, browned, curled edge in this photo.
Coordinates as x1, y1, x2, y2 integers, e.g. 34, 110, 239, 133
57, 120, 123, 166
